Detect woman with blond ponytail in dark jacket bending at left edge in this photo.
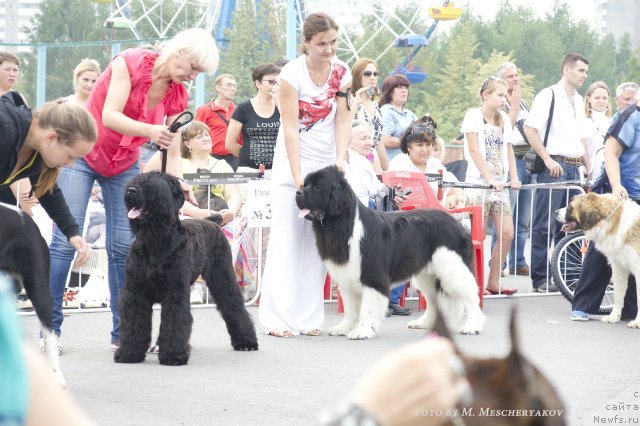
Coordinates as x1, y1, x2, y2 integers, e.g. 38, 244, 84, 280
0, 92, 98, 265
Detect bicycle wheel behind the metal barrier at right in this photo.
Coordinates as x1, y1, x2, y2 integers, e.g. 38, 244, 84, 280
551, 231, 613, 315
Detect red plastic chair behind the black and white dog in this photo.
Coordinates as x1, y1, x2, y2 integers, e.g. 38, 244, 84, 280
382, 171, 484, 309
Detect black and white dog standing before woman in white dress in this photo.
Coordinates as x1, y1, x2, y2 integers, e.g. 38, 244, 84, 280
296, 166, 485, 339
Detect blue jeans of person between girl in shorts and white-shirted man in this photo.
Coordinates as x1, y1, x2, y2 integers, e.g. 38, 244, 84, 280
509, 156, 537, 271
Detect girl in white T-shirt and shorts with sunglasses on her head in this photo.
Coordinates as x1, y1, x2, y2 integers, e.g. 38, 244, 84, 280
460, 77, 520, 295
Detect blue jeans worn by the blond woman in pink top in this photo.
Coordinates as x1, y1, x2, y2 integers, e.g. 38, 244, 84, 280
50, 159, 140, 343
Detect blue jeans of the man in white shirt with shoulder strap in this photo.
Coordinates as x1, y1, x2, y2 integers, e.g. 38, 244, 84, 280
531, 163, 580, 287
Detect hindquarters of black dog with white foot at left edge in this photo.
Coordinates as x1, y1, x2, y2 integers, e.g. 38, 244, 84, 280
0, 203, 66, 387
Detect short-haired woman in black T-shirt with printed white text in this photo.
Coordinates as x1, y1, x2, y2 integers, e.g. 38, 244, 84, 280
225, 63, 280, 203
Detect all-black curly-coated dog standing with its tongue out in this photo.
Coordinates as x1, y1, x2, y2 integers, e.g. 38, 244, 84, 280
114, 172, 258, 365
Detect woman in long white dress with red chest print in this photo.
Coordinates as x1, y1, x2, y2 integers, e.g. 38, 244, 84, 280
259, 13, 351, 337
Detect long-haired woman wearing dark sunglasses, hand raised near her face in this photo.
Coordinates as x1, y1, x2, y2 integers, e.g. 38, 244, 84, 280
351, 58, 389, 170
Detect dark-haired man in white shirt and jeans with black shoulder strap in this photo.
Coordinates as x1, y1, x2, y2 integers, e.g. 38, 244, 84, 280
524, 53, 589, 293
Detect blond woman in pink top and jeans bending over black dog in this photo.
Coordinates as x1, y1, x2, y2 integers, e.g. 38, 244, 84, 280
46, 29, 218, 350
